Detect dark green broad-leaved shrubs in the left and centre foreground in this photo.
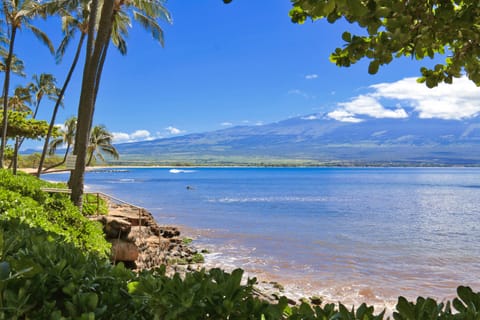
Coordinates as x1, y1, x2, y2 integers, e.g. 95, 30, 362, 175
0, 219, 286, 319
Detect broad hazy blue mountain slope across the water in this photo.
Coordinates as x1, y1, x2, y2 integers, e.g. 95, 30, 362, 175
116, 114, 480, 165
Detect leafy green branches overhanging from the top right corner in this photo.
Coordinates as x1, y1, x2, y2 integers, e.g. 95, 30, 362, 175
284, 0, 480, 88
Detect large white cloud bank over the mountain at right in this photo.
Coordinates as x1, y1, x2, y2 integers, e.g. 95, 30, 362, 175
329, 77, 480, 122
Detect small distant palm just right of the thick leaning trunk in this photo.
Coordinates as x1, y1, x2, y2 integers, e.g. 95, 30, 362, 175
87, 125, 120, 167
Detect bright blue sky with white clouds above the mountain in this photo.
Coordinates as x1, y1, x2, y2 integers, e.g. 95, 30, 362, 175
15, 0, 480, 148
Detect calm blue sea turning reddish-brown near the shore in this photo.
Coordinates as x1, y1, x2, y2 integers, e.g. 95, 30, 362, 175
45, 168, 480, 305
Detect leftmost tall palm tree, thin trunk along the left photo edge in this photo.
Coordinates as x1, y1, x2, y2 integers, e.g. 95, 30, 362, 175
0, 0, 55, 168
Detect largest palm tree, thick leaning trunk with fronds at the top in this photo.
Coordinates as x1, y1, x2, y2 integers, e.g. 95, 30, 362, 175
69, 0, 170, 209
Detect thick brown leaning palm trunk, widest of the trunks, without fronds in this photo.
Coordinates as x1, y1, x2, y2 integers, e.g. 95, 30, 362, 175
69, 0, 114, 210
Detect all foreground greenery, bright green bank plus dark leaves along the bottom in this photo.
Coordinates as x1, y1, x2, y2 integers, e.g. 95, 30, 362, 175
0, 171, 480, 320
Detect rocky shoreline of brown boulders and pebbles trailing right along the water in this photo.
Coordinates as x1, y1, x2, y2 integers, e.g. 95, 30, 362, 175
103, 203, 314, 305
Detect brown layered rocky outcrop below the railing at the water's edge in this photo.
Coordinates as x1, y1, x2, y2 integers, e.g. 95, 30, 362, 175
92, 203, 202, 272
